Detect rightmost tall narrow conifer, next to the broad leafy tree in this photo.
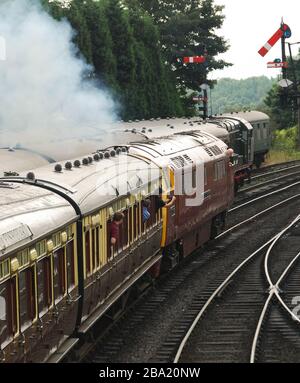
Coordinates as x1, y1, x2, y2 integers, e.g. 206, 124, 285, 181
129, 1, 183, 118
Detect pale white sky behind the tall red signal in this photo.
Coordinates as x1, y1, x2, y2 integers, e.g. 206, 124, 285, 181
210, 0, 300, 79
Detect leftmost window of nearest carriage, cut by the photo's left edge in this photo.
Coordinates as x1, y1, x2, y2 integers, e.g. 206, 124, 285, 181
0, 278, 17, 345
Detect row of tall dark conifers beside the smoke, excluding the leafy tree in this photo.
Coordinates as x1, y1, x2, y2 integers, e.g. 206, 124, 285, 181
43, 0, 183, 119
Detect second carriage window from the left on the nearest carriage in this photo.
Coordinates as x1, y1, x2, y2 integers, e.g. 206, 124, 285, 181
19, 267, 36, 327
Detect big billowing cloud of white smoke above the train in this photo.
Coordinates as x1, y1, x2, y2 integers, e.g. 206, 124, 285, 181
0, 0, 116, 156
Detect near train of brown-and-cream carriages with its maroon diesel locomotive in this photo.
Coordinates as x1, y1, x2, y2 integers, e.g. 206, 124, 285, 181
0, 128, 234, 362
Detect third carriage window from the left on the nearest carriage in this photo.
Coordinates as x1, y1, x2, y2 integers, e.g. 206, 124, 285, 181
37, 257, 52, 312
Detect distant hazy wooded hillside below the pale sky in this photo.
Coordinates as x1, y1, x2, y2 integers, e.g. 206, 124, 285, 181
212, 76, 274, 114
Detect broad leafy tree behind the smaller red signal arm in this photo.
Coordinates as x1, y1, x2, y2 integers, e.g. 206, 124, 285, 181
139, 0, 230, 94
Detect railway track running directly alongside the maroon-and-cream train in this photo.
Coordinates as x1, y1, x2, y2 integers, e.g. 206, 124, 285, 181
75, 179, 300, 363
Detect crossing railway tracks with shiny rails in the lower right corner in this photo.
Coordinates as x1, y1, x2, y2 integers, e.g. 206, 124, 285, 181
174, 216, 300, 363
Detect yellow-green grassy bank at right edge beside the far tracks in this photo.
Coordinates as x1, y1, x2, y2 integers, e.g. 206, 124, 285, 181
266, 127, 300, 165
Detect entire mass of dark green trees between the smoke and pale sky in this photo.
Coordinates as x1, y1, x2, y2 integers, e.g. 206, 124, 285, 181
41, 0, 228, 119
